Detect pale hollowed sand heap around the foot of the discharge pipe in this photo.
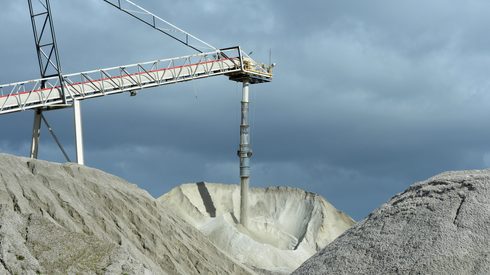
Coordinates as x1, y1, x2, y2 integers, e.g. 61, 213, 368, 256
158, 182, 354, 273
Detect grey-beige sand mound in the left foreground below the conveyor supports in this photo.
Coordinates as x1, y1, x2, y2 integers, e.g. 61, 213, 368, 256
0, 154, 251, 274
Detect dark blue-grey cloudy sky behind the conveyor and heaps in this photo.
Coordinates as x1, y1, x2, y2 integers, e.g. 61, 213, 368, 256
0, 0, 490, 219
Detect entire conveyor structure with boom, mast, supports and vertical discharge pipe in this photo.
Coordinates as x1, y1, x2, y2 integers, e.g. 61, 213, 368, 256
0, 0, 273, 227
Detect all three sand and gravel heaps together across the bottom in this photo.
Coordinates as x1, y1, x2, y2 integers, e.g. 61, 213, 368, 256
0, 154, 484, 274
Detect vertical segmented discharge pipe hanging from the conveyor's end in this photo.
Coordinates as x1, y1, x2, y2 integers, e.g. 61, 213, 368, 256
238, 81, 252, 228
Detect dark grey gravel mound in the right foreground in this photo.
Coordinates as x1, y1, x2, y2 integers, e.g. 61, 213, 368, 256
295, 170, 490, 274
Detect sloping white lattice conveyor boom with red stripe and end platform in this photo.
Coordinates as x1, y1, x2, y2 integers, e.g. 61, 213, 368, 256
0, 47, 272, 115
